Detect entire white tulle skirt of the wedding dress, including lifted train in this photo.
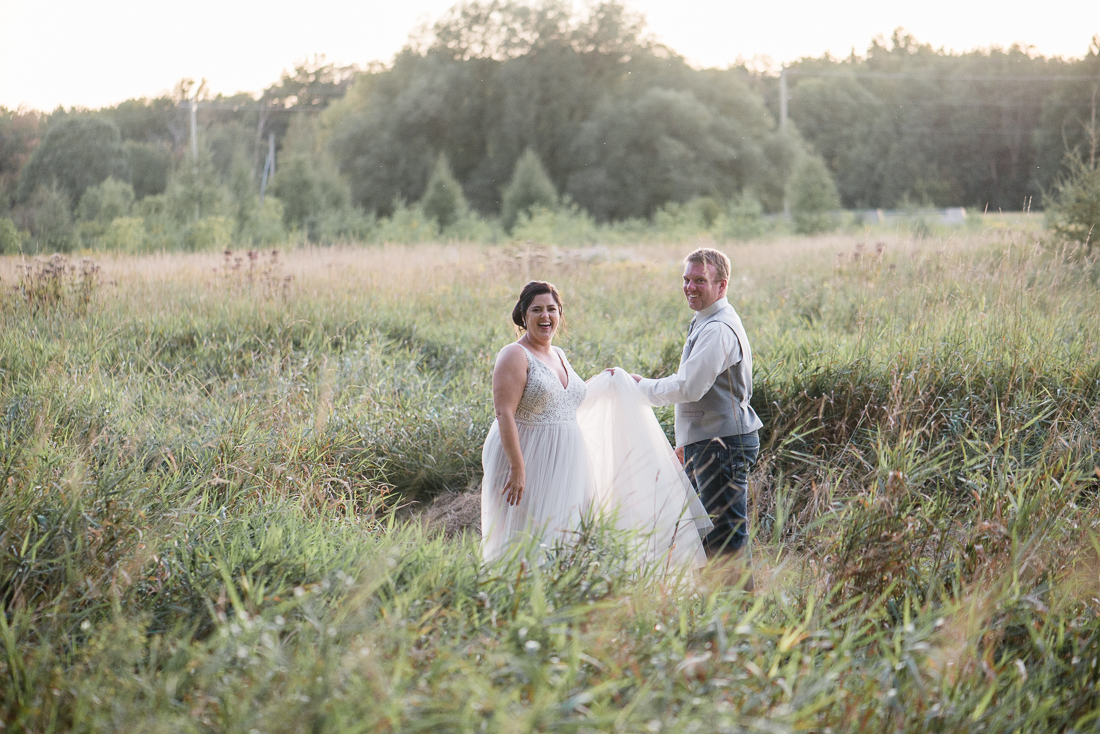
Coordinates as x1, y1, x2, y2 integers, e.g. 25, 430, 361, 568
482, 369, 713, 572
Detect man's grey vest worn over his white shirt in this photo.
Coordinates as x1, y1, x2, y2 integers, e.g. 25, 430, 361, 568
677, 306, 763, 446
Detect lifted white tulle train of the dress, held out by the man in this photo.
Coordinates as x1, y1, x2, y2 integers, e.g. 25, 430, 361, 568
576, 368, 714, 571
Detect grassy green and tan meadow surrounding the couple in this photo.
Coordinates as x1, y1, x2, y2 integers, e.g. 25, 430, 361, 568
0, 217, 1100, 733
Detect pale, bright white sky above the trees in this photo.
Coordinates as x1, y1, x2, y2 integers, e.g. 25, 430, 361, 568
0, 0, 1100, 110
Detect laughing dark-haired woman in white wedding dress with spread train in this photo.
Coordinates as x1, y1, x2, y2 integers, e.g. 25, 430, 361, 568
482, 281, 712, 567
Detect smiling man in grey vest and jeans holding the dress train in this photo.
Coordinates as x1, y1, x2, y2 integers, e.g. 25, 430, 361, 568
630, 249, 763, 567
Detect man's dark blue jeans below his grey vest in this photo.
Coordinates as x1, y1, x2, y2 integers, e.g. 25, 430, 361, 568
684, 431, 760, 554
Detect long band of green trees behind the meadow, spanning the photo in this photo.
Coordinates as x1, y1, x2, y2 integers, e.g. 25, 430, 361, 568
0, 0, 1100, 255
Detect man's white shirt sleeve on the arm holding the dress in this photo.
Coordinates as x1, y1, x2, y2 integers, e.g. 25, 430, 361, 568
638, 324, 741, 406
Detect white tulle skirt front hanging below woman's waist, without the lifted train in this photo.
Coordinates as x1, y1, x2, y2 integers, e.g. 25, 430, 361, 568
482, 420, 592, 561
